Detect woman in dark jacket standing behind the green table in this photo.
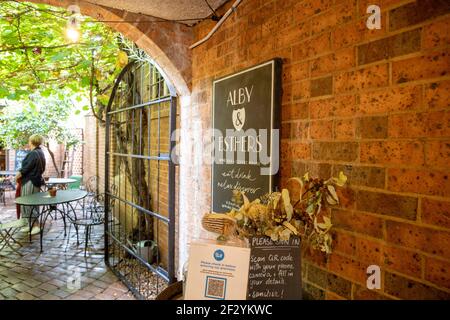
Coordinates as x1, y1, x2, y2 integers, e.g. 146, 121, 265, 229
16, 134, 45, 234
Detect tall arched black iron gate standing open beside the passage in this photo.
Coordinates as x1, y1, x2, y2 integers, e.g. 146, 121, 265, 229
105, 62, 176, 299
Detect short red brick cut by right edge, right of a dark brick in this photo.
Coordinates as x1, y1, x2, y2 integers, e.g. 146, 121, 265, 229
422, 198, 450, 229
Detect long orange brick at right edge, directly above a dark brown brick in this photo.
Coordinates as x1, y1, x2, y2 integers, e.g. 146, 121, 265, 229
388, 169, 450, 197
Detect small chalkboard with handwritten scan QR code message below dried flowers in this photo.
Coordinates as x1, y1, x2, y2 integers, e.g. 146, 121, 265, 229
247, 237, 302, 300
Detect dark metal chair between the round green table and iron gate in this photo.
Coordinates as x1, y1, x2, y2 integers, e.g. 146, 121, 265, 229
67, 185, 118, 256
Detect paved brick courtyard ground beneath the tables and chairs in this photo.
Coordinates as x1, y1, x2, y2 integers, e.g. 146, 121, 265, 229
0, 190, 134, 300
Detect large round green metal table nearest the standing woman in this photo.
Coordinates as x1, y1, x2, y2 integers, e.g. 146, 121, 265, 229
15, 190, 88, 252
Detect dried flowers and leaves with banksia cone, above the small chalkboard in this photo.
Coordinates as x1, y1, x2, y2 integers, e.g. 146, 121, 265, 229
203, 172, 347, 253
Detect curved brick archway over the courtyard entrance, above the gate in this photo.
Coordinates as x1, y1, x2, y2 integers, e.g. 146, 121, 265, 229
21, 0, 193, 96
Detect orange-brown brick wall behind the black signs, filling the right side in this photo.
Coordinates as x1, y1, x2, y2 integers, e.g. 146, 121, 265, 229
190, 0, 450, 299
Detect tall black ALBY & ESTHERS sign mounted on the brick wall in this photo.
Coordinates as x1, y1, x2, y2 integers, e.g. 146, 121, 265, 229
211, 59, 281, 213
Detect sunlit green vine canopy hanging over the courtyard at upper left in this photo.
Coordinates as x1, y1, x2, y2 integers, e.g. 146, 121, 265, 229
0, 1, 124, 109
